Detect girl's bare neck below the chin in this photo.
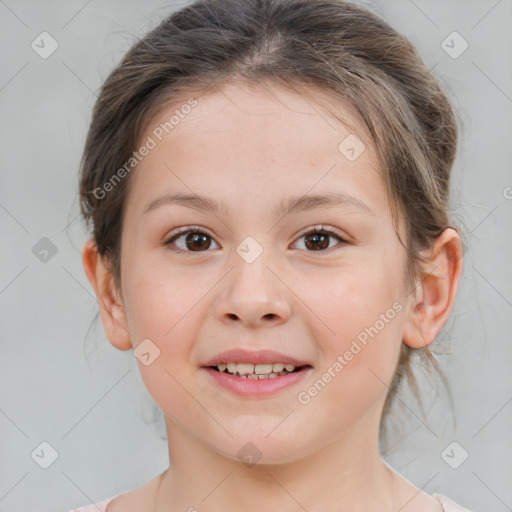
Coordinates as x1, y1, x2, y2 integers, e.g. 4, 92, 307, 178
155, 422, 395, 512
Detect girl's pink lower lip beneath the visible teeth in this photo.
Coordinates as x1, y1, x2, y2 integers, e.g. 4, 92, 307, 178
202, 366, 313, 397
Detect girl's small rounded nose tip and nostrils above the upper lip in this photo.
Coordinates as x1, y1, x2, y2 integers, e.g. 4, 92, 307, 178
215, 252, 292, 328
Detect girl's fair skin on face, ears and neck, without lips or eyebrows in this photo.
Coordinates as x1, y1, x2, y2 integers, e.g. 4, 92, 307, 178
83, 84, 462, 512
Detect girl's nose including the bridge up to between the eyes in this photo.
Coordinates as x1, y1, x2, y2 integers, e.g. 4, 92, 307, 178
216, 237, 291, 325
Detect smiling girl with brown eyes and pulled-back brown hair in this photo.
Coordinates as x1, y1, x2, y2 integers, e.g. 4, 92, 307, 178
72, 0, 467, 512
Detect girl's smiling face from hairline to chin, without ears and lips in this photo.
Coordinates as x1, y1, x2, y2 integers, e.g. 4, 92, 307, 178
112, 85, 407, 463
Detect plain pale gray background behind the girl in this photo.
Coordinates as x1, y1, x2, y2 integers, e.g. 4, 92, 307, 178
0, 0, 512, 512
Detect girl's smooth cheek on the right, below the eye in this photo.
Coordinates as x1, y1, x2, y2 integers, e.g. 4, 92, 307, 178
303, 261, 405, 396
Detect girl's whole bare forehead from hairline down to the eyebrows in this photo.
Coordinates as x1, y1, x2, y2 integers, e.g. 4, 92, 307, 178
126, 79, 382, 214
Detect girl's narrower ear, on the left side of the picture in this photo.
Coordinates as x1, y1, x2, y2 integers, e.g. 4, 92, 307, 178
82, 239, 133, 350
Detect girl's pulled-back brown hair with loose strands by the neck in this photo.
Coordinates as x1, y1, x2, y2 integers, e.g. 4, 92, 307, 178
80, 0, 464, 440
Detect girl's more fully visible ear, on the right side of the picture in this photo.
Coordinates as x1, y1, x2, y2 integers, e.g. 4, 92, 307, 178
402, 228, 463, 348
